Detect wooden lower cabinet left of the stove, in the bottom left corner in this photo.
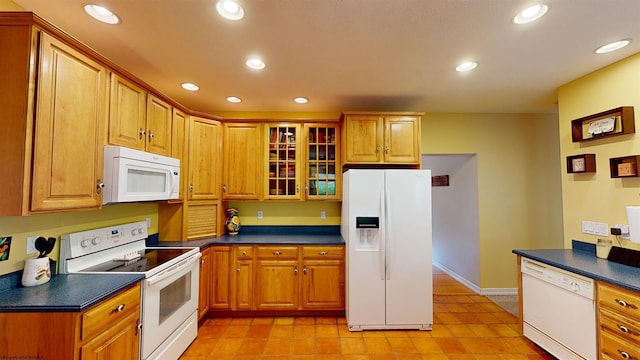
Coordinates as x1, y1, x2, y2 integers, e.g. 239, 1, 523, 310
0, 284, 140, 360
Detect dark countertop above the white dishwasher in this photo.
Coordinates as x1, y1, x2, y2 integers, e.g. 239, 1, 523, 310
512, 244, 640, 292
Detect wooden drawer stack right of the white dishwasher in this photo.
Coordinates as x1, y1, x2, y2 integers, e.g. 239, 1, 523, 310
597, 282, 640, 360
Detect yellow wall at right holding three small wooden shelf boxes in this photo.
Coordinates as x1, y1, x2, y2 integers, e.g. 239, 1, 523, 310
558, 53, 640, 248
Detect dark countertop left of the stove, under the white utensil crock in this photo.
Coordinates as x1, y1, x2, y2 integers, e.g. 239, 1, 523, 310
0, 274, 144, 312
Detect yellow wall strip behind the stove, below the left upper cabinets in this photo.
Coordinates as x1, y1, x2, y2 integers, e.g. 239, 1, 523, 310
0, 203, 158, 275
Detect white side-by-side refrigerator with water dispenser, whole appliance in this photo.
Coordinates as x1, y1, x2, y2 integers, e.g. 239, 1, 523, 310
340, 169, 433, 331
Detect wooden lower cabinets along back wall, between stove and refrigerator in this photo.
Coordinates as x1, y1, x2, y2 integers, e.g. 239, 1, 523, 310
209, 245, 345, 313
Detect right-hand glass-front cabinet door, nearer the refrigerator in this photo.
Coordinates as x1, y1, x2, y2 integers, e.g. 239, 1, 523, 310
304, 123, 342, 200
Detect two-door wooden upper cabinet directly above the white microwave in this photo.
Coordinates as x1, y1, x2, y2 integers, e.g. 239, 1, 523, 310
108, 73, 173, 156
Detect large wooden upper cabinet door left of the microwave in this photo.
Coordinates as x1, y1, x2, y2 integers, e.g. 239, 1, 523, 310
31, 33, 107, 212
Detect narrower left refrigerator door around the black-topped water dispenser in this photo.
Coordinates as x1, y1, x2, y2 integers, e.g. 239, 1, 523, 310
342, 170, 385, 326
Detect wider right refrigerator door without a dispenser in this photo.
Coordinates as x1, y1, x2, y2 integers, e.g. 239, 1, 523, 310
385, 170, 433, 328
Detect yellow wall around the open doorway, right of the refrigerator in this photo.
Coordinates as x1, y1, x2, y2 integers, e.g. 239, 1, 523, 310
422, 113, 562, 289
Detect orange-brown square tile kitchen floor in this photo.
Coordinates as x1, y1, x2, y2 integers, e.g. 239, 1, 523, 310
181, 268, 554, 360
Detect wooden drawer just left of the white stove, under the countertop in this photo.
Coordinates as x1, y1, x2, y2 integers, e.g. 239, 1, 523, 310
82, 284, 140, 340
